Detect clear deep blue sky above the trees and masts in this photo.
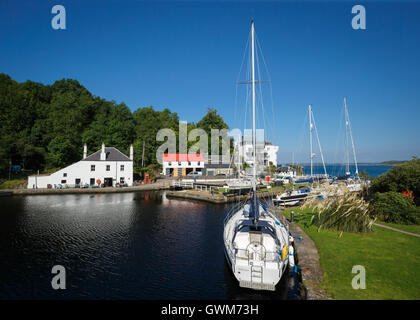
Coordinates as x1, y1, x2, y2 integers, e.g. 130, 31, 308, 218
0, 0, 420, 163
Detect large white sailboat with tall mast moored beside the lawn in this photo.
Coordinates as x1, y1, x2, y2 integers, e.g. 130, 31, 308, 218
223, 21, 293, 290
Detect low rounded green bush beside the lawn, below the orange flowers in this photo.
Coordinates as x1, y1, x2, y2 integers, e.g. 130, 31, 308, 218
369, 191, 420, 224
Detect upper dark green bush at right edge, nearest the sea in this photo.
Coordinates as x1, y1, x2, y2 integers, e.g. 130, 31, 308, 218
370, 157, 420, 205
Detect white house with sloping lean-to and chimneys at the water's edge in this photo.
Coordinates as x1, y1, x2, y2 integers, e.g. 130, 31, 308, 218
28, 143, 133, 189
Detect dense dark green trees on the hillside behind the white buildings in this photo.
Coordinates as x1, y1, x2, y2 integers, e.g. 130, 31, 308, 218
0, 74, 228, 173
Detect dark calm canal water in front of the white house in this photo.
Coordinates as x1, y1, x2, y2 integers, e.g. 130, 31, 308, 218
0, 192, 300, 299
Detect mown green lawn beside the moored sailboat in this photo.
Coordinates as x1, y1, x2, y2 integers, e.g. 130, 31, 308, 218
285, 208, 420, 300
